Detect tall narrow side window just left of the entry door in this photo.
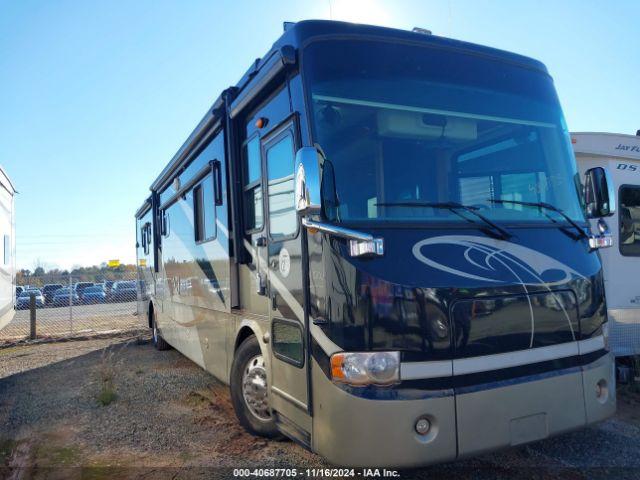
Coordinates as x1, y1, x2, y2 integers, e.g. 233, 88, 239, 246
243, 136, 264, 231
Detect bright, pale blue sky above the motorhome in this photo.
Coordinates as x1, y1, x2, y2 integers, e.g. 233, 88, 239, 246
0, 0, 640, 269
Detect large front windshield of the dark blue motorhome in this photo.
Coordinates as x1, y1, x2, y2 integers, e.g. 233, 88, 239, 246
303, 40, 584, 222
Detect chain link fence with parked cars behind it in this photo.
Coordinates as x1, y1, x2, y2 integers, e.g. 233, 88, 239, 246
0, 272, 145, 344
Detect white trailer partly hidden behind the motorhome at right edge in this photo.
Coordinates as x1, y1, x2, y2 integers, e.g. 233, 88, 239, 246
571, 131, 640, 357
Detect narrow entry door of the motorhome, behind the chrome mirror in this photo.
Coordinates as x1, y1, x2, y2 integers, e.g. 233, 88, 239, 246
263, 121, 311, 442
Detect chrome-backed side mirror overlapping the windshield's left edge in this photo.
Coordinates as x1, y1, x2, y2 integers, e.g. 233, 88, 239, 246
295, 147, 322, 215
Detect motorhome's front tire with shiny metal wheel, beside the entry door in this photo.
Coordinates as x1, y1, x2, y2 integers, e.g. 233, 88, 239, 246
230, 336, 279, 438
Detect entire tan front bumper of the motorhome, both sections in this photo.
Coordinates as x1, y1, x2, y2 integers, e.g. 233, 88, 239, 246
312, 355, 615, 468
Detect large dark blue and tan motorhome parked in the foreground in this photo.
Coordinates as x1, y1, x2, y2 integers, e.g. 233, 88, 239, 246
136, 21, 615, 467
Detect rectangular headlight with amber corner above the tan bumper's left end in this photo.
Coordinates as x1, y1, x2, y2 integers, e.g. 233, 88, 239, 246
331, 352, 400, 387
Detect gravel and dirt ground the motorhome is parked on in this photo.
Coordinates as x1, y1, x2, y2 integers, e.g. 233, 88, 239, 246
0, 337, 640, 479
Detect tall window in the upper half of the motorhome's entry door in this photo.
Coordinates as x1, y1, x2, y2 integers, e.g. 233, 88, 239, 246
266, 132, 298, 240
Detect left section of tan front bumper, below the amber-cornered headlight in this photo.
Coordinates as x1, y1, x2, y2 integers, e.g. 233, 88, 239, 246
312, 361, 456, 467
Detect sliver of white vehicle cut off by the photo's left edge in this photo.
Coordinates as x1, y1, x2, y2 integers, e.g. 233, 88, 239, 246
0, 167, 16, 329
